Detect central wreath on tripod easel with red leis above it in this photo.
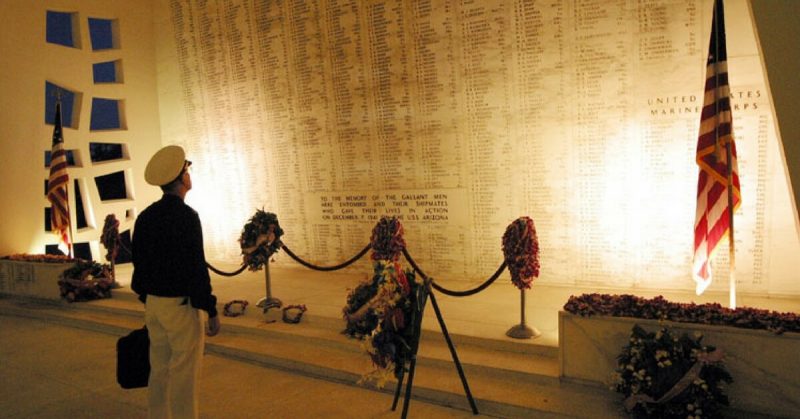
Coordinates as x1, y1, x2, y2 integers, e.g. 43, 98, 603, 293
342, 217, 422, 388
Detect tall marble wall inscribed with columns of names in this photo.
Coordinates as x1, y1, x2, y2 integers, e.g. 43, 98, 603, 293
158, 0, 800, 294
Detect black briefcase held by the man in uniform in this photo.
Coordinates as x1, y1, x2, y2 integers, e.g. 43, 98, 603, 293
117, 327, 150, 388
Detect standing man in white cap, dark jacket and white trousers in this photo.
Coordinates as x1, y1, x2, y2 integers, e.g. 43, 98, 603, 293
131, 146, 220, 419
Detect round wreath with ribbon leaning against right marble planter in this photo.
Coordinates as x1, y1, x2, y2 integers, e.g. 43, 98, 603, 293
613, 325, 733, 419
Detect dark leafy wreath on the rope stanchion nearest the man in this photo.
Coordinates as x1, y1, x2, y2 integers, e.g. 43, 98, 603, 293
239, 209, 283, 271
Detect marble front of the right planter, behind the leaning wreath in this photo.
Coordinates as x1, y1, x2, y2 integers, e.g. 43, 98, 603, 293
559, 311, 800, 417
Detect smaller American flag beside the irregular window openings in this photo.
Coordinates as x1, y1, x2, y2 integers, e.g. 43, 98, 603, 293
47, 101, 70, 248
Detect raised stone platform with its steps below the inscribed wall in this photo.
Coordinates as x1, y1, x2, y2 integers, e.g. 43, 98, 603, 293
0, 265, 796, 418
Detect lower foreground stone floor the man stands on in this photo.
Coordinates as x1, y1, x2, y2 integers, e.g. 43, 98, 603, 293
0, 315, 485, 419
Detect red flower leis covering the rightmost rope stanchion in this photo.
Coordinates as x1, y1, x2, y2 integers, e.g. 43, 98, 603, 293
503, 217, 539, 290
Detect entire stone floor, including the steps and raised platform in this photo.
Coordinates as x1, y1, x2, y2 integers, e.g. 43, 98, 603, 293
0, 265, 800, 418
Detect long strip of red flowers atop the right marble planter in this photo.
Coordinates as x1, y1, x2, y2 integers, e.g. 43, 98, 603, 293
564, 294, 800, 334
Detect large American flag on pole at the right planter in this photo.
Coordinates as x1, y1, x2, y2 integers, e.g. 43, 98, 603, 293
693, 0, 742, 295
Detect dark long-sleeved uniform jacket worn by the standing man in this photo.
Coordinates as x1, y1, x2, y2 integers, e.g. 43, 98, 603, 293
131, 194, 217, 317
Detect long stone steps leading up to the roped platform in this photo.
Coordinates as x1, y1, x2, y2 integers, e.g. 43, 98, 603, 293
0, 293, 619, 418
